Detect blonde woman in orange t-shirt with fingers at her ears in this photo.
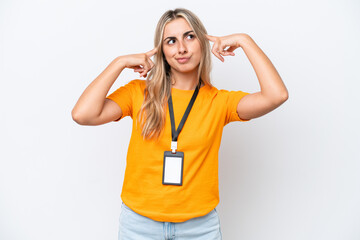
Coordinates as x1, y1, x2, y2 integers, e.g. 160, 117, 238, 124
72, 8, 288, 240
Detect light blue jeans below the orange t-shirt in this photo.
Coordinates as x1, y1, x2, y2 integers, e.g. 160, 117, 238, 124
118, 203, 222, 240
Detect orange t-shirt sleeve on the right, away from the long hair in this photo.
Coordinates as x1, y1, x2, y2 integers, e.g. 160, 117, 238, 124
221, 90, 250, 125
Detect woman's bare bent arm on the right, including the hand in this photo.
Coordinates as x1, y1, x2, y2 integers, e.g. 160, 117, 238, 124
206, 33, 289, 120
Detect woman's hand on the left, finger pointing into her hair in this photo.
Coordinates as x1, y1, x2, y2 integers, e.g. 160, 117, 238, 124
119, 48, 157, 77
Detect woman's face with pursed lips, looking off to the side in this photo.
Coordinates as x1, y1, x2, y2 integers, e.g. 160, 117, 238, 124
162, 17, 201, 73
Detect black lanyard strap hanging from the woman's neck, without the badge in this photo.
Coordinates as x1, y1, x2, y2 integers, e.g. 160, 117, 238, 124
168, 81, 201, 153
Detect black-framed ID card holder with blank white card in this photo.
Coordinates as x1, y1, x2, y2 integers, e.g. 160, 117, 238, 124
162, 151, 184, 186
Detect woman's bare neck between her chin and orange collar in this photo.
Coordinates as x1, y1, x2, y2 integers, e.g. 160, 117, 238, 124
171, 71, 199, 90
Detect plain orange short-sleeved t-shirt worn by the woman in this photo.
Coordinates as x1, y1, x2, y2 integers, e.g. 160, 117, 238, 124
106, 79, 249, 222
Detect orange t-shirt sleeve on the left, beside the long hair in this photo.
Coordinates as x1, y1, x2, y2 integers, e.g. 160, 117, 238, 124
106, 80, 137, 122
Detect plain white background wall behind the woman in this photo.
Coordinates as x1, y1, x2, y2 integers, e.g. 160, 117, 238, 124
0, 0, 360, 240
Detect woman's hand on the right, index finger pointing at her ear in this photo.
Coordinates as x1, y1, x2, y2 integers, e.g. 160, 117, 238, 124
205, 33, 248, 62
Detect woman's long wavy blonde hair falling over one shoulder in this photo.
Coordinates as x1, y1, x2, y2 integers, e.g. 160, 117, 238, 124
137, 8, 212, 139
